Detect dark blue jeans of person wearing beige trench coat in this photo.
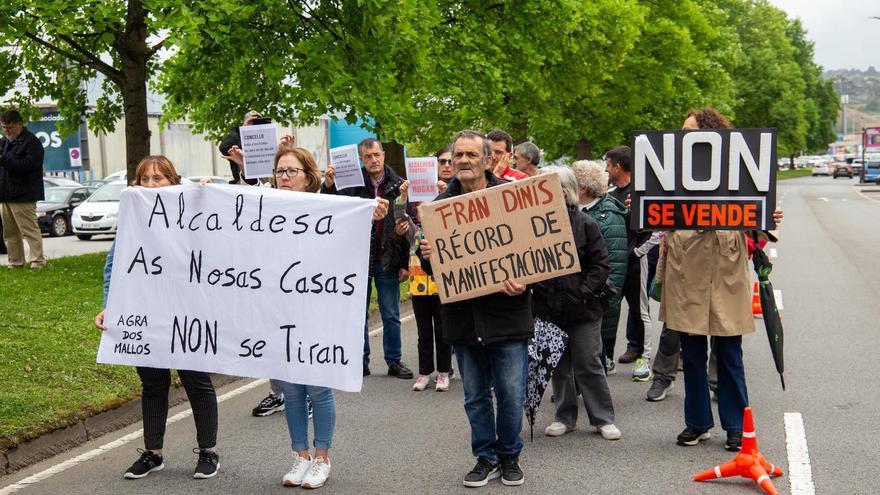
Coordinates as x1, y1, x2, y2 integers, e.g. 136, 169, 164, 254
680, 333, 749, 431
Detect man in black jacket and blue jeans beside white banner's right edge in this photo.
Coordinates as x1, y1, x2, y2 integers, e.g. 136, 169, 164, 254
321, 138, 413, 379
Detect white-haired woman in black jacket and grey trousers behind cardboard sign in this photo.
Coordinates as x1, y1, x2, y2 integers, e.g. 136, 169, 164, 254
532, 167, 620, 440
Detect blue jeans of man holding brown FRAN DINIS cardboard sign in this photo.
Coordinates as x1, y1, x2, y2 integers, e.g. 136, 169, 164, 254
454, 340, 528, 464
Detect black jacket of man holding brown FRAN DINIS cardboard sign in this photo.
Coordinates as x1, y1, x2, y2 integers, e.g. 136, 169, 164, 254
420, 172, 535, 345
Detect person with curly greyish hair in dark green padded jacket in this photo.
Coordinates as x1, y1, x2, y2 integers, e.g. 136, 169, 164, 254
571, 160, 629, 375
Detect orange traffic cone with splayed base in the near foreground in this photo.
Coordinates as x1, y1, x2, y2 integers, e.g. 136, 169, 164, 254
694, 407, 782, 495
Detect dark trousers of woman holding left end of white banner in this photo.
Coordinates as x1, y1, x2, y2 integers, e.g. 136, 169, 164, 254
137, 367, 217, 450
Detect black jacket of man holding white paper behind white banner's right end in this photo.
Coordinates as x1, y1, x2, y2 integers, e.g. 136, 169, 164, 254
321, 165, 409, 272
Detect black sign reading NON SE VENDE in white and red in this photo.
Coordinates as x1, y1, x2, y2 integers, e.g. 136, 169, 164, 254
630, 129, 777, 230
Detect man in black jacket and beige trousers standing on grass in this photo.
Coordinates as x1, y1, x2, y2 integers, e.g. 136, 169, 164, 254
0, 110, 46, 269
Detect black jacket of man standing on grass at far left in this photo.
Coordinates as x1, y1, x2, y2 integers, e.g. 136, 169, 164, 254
0, 127, 45, 203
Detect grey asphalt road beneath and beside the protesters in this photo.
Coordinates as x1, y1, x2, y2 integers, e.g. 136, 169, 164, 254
0, 177, 880, 495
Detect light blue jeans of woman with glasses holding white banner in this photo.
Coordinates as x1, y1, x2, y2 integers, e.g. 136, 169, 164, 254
278, 381, 336, 452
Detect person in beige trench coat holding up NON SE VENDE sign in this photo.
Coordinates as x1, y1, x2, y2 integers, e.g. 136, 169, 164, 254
659, 108, 782, 451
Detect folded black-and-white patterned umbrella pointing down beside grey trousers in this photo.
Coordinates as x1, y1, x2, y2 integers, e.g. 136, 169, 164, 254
525, 318, 568, 440
